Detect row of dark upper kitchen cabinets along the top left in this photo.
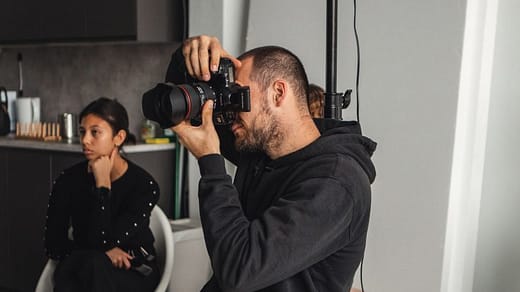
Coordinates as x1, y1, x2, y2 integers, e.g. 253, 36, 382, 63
0, 0, 184, 44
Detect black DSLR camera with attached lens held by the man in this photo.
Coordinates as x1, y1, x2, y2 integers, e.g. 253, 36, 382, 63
142, 58, 251, 129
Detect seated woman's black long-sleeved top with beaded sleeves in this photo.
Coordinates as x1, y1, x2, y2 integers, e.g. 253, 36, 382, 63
45, 161, 159, 260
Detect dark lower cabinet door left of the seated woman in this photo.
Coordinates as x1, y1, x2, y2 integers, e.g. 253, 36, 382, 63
7, 149, 51, 291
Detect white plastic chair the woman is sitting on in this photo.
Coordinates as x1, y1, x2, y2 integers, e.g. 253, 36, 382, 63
35, 206, 174, 292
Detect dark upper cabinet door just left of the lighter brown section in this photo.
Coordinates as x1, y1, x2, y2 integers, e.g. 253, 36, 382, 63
85, 0, 137, 40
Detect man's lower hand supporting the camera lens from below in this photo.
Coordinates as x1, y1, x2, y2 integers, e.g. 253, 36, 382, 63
171, 100, 220, 159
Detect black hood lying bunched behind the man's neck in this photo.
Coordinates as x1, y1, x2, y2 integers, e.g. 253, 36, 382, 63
270, 119, 377, 183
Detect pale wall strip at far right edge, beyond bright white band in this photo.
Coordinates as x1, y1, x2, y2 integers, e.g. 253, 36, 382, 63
473, 0, 520, 292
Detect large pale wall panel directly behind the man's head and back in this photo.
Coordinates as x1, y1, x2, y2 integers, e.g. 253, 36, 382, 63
247, 0, 465, 291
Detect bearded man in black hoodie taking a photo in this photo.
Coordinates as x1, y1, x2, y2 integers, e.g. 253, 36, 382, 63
148, 36, 376, 292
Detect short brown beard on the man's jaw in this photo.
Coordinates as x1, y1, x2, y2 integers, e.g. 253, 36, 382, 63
235, 102, 284, 152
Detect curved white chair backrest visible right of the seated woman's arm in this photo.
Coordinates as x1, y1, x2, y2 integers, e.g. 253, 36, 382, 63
150, 206, 175, 292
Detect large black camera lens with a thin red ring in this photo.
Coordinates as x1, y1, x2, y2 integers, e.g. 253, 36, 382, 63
142, 83, 215, 129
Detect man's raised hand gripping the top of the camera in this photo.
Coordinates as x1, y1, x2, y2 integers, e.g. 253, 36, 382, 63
182, 35, 242, 81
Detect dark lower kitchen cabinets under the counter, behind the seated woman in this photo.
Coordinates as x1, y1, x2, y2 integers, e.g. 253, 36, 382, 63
0, 147, 175, 291
